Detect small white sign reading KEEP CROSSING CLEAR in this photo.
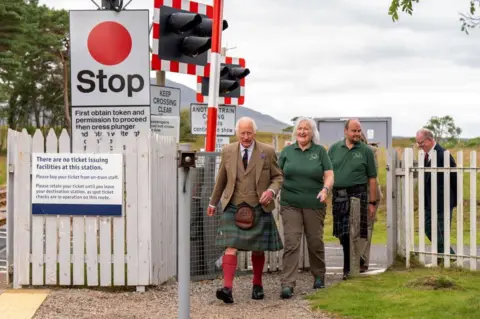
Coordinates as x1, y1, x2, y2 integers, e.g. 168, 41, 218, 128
150, 85, 180, 116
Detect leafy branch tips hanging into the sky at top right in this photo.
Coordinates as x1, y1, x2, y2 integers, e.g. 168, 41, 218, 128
388, 0, 480, 34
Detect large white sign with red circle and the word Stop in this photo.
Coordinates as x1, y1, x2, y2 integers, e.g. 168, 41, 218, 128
70, 10, 150, 106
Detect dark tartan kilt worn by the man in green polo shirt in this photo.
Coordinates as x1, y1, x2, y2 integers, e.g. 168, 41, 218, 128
332, 189, 368, 238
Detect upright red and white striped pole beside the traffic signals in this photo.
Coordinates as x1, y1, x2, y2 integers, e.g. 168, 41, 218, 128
205, 0, 223, 152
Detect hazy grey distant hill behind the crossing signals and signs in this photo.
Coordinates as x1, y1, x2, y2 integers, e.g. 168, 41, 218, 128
150, 78, 290, 133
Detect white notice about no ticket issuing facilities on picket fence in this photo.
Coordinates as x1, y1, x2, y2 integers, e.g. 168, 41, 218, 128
31, 153, 123, 216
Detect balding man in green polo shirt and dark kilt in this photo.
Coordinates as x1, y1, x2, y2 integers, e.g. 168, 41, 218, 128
328, 120, 377, 280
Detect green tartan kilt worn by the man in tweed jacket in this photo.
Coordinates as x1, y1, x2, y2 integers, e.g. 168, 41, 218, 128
216, 204, 283, 251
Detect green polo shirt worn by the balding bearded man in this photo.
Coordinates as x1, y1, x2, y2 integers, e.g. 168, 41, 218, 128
328, 139, 377, 187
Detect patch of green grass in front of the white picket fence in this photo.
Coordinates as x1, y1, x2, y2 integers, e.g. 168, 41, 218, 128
308, 268, 480, 319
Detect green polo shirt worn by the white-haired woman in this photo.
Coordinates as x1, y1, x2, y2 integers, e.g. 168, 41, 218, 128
279, 143, 332, 209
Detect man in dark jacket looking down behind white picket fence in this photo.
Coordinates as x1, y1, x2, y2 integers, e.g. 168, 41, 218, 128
416, 129, 457, 262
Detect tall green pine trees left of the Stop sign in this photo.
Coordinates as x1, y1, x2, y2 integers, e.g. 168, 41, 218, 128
0, 0, 70, 129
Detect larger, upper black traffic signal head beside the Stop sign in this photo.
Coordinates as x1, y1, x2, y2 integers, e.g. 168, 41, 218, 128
158, 6, 228, 66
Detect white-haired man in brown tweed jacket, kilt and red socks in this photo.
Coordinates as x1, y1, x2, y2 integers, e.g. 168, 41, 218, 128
208, 117, 283, 303
